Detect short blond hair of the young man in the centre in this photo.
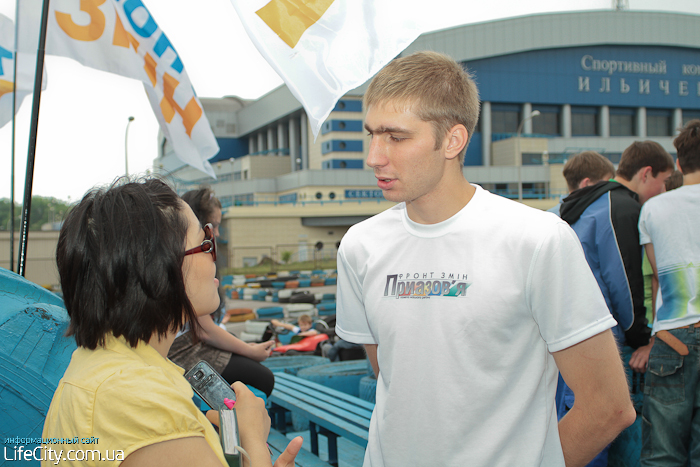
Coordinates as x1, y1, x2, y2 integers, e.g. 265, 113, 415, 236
363, 51, 479, 164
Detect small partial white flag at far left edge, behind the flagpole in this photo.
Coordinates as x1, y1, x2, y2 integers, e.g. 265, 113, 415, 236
0, 14, 46, 128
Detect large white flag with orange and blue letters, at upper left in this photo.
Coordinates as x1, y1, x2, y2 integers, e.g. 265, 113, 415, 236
20, 0, 219, 178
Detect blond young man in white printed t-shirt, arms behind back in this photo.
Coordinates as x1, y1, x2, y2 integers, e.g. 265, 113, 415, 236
336, 52, 635, 467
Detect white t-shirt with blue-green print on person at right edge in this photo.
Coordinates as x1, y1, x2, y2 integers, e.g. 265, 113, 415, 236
639, 185, 700, 334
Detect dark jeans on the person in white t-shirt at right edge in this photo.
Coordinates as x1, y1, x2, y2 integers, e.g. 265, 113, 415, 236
641, 326, 700, 467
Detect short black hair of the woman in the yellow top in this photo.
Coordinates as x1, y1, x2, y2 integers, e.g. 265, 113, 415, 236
56, 178, 198, 349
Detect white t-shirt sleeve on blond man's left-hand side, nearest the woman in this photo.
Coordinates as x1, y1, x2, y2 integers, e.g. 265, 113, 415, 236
335, 243, 377, 344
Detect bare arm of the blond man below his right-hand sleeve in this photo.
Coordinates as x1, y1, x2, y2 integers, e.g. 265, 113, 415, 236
552, 330, 636, 467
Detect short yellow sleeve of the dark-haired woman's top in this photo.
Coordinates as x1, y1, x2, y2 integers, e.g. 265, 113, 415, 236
93, 367, 215, 458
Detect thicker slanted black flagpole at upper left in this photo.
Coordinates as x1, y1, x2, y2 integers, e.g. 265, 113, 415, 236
17, 0, 49, 277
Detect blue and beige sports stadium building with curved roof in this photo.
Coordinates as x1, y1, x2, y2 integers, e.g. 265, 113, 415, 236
154, 10, 700, 267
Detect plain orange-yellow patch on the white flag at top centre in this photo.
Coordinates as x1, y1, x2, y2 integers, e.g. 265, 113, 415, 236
255, 0, 334, 48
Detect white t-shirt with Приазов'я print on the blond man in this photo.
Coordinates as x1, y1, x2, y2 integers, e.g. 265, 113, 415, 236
336, 186, 617, 467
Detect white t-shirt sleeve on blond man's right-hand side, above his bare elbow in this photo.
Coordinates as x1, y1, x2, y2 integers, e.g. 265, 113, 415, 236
527, 222, 617, 352
